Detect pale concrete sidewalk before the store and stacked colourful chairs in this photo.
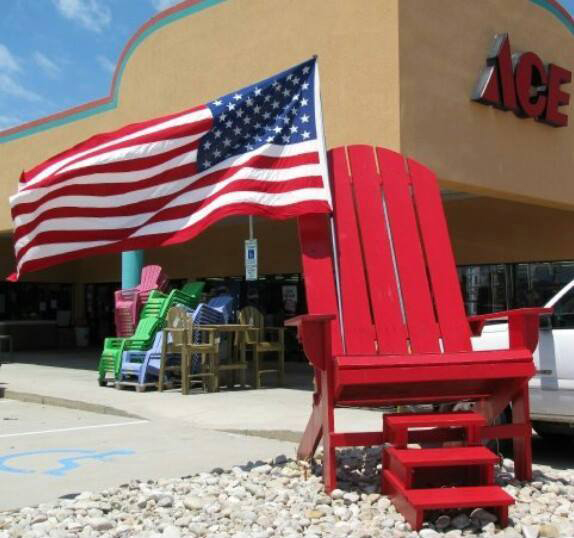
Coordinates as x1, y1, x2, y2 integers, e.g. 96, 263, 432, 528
0, 350, 388, 442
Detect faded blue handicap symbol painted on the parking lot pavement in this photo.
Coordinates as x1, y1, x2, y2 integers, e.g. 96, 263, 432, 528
0, 448, 135, 476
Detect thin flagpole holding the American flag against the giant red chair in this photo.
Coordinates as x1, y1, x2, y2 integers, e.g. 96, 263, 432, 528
313, 54, 347, 353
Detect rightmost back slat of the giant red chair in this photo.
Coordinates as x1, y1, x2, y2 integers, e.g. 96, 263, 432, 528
408, 159, 472, 351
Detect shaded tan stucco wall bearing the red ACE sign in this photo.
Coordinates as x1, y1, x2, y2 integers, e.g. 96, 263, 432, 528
399, 0, 574, 208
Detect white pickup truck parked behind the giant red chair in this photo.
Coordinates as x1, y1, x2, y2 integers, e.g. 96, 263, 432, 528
472, 280, 574, 438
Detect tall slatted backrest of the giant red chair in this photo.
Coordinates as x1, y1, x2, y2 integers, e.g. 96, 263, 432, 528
299, 146, 471, 355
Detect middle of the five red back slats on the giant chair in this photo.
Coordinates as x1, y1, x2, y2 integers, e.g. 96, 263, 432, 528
349, 146, 408, 354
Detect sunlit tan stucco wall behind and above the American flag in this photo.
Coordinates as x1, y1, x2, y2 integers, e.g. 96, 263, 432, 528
0, 0, 399, 231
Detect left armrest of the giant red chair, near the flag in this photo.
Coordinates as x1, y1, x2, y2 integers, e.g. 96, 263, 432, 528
285, 314, 337, 370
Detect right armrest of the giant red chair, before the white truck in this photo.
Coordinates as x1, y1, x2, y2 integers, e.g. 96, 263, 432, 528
468, 308, 552, 352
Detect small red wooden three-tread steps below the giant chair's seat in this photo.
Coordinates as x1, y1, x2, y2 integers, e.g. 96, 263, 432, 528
381, 412, 514, 530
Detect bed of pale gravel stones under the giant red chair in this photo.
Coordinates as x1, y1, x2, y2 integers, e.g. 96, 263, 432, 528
0, 448, 574, 538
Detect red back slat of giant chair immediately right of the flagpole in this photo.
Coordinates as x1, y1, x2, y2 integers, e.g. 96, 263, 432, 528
330, 148, 376, 355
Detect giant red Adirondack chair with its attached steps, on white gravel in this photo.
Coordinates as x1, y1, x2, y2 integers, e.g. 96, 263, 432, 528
287, 146, 547, 528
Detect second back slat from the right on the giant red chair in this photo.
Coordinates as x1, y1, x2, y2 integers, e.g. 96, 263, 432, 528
377, 148, 440, 353
